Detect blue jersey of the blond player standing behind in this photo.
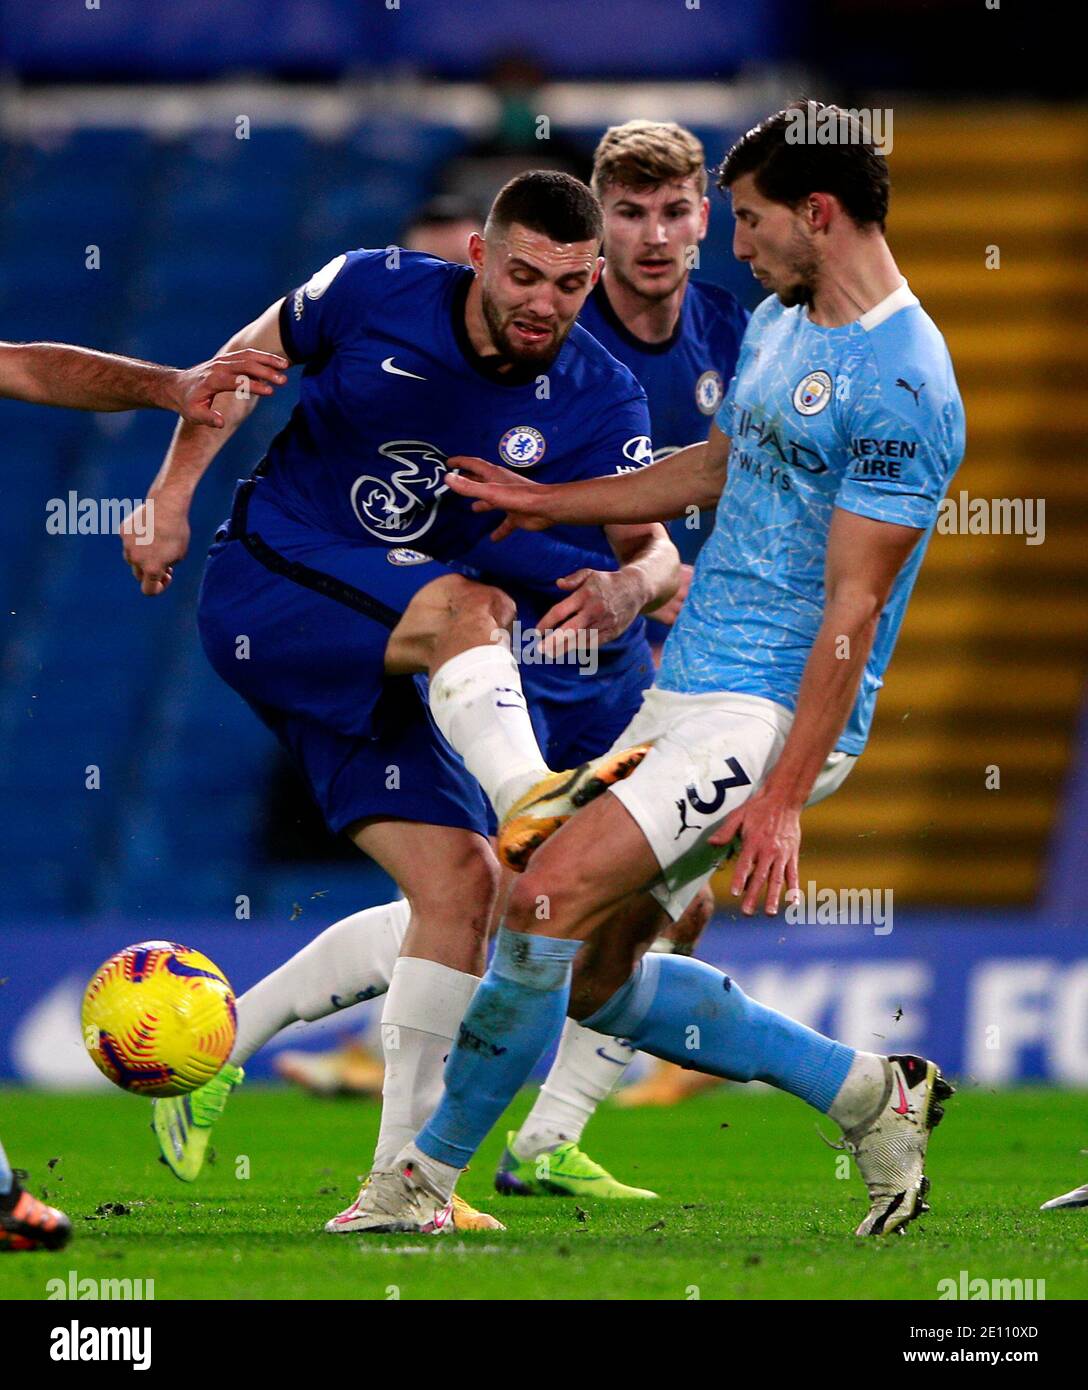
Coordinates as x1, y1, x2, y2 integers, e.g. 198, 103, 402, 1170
578, 277, 748, 563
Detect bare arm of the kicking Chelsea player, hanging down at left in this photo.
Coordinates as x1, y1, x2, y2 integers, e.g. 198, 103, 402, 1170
122, 299, 285, 596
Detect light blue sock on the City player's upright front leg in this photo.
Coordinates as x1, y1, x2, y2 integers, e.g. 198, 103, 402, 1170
415, 927, 582, 1168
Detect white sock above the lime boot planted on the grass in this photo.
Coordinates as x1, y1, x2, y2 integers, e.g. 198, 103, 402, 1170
513, 1019, 636, 1162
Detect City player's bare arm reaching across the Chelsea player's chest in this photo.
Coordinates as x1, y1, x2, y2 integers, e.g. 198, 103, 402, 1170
447, 425, 730, 539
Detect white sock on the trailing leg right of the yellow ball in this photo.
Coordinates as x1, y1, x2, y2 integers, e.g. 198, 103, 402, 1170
231, 898, 411, 1066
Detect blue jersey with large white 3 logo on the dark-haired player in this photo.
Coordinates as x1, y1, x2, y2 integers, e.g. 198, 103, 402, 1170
260, 250, 650, 567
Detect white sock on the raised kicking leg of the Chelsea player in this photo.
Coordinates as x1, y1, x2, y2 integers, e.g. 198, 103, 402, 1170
431, 638, 549, 820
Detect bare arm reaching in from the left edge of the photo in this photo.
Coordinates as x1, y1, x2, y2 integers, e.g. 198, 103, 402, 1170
0, 343, 288, 428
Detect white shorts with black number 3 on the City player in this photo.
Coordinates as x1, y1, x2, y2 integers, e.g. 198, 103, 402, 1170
609, 685, 857, 922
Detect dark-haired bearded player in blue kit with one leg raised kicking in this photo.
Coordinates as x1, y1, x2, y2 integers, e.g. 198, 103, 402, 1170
126, 172, 677, 1229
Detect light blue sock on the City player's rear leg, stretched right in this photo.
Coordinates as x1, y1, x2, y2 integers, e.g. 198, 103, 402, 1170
582, 955, 855, 1113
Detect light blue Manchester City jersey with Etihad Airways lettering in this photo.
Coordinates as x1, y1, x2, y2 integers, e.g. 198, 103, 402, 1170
657, 285, 964, 753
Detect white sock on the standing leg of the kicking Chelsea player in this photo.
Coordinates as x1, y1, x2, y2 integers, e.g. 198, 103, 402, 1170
374, 956, 479, 1170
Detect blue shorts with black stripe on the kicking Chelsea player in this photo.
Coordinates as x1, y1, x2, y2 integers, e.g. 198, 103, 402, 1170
197, 478, 653, 835
